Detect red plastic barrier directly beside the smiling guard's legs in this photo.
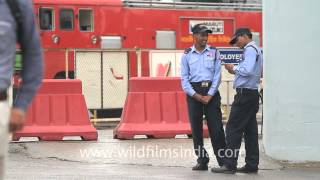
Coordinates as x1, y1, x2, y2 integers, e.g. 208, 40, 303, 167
114, 77, 208, 139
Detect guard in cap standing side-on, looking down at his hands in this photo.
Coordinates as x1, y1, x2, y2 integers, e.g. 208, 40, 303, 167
211, 28, 263, 174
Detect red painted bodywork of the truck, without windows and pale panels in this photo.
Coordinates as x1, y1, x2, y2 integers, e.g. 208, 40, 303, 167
33, 0, 262, 78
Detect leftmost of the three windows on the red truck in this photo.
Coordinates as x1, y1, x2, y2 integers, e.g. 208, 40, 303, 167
39, 8, 54, 30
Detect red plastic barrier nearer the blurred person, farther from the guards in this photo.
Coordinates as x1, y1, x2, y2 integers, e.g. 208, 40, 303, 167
12, 79, 98, 141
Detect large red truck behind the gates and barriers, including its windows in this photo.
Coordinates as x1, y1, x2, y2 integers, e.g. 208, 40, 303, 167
33, 0, 262, 78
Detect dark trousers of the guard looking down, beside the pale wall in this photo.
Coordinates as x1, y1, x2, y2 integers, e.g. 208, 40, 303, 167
224, 90, 259, 169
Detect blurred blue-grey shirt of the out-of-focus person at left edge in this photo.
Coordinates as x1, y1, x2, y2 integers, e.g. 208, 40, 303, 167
0, 0, 43, 111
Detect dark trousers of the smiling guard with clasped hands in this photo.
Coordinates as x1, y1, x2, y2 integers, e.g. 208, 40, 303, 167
187, 91, 226, 165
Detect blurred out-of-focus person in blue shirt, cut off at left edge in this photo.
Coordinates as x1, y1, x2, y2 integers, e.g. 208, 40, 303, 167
0, 0, 44, 180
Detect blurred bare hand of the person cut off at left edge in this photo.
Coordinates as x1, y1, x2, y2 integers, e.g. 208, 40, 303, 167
9, 108, 25, 132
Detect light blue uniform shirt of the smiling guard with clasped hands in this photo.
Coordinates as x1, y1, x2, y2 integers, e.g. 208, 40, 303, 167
181, 45, 221, 96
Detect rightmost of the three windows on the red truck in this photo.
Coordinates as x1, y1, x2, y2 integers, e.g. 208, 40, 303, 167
79, 9, 93, 31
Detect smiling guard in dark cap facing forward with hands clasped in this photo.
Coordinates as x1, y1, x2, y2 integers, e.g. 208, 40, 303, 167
181, 24, 226, 170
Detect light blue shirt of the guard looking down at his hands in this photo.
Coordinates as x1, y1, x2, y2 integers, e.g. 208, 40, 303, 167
233, 41, 263, 89
